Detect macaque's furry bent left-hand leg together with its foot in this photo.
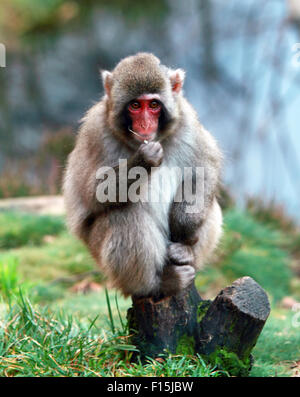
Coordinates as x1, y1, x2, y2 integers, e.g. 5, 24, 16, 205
93, 207, 195, 297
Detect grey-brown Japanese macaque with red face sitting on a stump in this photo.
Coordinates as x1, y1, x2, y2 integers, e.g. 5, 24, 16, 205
64, 53, 222, 297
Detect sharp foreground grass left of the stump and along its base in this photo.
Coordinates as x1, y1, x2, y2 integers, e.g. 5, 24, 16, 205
0, 293, 221, 377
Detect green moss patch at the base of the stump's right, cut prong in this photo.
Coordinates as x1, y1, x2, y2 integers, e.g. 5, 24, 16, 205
207, 348, 251, 376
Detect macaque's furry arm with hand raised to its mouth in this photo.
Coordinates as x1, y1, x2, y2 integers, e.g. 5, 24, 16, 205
63, 137, 163, 238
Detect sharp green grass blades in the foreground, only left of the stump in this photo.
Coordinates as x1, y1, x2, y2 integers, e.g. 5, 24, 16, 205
0, 294, 133, 376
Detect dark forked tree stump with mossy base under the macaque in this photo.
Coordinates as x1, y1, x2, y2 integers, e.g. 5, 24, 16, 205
128, 277, 270, 376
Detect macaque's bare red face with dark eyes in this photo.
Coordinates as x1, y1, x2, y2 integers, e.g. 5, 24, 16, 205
128, 94, 161, 141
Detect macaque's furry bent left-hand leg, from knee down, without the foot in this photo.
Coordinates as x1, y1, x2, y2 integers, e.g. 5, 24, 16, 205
95, 207, 167, 296
